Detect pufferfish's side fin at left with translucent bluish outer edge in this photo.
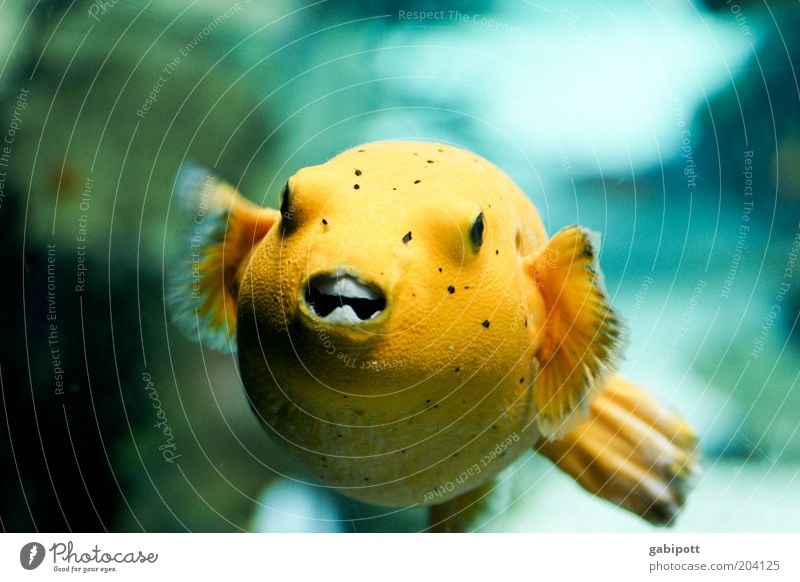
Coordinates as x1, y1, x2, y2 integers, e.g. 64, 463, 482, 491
169, 165, 280, 351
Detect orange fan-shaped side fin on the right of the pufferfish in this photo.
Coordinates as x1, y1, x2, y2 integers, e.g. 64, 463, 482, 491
525, 226, 620, 437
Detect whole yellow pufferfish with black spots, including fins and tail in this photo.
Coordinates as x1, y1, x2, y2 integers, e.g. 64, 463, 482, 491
171, 141, 698, 531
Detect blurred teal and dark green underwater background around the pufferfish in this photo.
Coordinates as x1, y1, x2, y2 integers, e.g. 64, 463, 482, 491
0, 0, 800, 532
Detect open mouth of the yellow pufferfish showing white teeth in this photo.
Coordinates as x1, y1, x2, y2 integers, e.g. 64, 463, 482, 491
303, 271, 386, 325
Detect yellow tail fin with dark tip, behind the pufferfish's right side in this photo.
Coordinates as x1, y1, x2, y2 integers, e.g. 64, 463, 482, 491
537, 376, 700, 525
